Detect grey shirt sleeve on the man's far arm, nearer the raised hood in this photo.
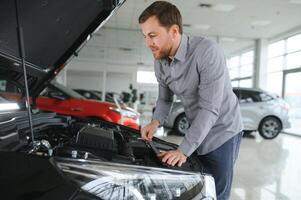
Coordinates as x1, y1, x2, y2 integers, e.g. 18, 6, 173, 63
153, 61, 174, 126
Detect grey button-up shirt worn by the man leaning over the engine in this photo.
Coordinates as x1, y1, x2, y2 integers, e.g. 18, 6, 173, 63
153, 34, 243, 156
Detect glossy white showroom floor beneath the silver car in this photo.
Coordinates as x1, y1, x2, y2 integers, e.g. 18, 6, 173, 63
158, 133, 301, 200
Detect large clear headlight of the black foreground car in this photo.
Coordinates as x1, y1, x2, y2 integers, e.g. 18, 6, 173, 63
54, 158, 216, 200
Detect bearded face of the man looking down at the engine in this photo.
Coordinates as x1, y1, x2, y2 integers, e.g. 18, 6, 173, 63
140, 16, 173, 59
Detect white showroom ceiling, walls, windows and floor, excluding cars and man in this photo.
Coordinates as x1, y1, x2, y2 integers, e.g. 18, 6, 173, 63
51, 0, 301, 200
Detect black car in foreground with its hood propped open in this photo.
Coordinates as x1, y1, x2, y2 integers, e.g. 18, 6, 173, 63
0, 0, 216, 200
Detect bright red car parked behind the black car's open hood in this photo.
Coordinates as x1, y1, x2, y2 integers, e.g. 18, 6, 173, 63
36, 83, 139, 130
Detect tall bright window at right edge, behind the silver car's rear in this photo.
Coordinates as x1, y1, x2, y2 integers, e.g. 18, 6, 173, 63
267, 34, 301, 135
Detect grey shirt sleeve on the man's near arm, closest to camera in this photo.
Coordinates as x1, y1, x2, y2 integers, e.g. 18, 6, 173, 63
179, 44, 227, 156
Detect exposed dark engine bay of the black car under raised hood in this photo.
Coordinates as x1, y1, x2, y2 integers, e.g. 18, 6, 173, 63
0, 113, 201, 171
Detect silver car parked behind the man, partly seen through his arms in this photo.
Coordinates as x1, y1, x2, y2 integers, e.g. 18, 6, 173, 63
164, 88, 290, 139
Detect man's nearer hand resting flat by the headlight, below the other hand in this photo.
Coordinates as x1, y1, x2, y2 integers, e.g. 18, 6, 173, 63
159, 149, 187, 167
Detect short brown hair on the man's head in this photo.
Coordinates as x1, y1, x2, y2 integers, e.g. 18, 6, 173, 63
139, 1, 183, 34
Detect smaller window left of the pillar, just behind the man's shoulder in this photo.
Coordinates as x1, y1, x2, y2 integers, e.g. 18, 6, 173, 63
227, 50, 254, 88
